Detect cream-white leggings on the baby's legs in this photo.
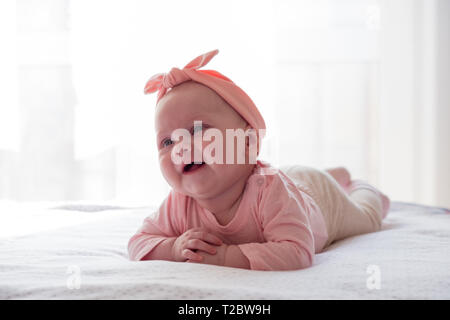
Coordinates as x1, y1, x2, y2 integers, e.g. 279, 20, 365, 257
280, 165, 384, 248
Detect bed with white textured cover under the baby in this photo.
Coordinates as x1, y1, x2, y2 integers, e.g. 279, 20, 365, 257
0, 202, 450, 300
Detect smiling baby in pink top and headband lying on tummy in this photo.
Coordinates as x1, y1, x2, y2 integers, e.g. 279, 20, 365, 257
128, 50, 390, 270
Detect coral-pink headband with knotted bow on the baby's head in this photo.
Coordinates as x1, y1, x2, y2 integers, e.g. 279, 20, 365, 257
144, 50, 266, 139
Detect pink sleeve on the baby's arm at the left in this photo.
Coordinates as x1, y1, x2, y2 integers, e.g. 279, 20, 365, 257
128, 191, 185, 261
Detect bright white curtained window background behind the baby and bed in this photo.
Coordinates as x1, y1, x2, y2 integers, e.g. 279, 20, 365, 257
0, 0, 450, 207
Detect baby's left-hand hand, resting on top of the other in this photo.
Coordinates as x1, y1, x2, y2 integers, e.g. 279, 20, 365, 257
172, 228, 222, 262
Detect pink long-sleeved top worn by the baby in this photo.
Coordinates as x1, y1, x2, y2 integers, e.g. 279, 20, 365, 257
128, 160, 328, 270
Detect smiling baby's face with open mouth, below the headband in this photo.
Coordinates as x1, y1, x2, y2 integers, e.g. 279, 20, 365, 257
155, 81, 254, 199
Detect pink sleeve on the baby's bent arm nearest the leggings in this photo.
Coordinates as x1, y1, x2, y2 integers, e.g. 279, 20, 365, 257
239, 175, 314, 270
